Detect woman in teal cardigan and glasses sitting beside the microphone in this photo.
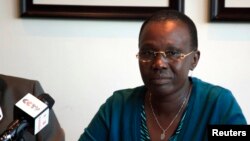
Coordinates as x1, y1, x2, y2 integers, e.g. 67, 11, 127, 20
79, 10, 246, 141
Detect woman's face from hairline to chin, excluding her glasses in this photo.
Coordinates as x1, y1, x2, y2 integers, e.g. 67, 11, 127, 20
139, 20, 195, 94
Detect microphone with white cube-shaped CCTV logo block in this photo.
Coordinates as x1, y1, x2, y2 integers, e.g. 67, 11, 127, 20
0, 93, 55, 141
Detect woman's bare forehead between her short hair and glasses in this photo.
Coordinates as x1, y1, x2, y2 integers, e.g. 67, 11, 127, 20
139, 21, 191, 48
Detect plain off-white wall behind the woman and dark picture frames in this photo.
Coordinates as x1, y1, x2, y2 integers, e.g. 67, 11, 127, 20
0, 0, 250, 141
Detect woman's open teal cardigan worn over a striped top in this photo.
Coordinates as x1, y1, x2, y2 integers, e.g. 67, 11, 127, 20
79, 77, 247, 141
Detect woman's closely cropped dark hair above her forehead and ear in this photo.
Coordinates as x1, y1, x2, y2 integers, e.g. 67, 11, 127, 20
139, 10, 198, 49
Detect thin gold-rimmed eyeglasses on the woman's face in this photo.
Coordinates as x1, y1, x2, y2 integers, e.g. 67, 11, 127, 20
136, 50, 194, 62
